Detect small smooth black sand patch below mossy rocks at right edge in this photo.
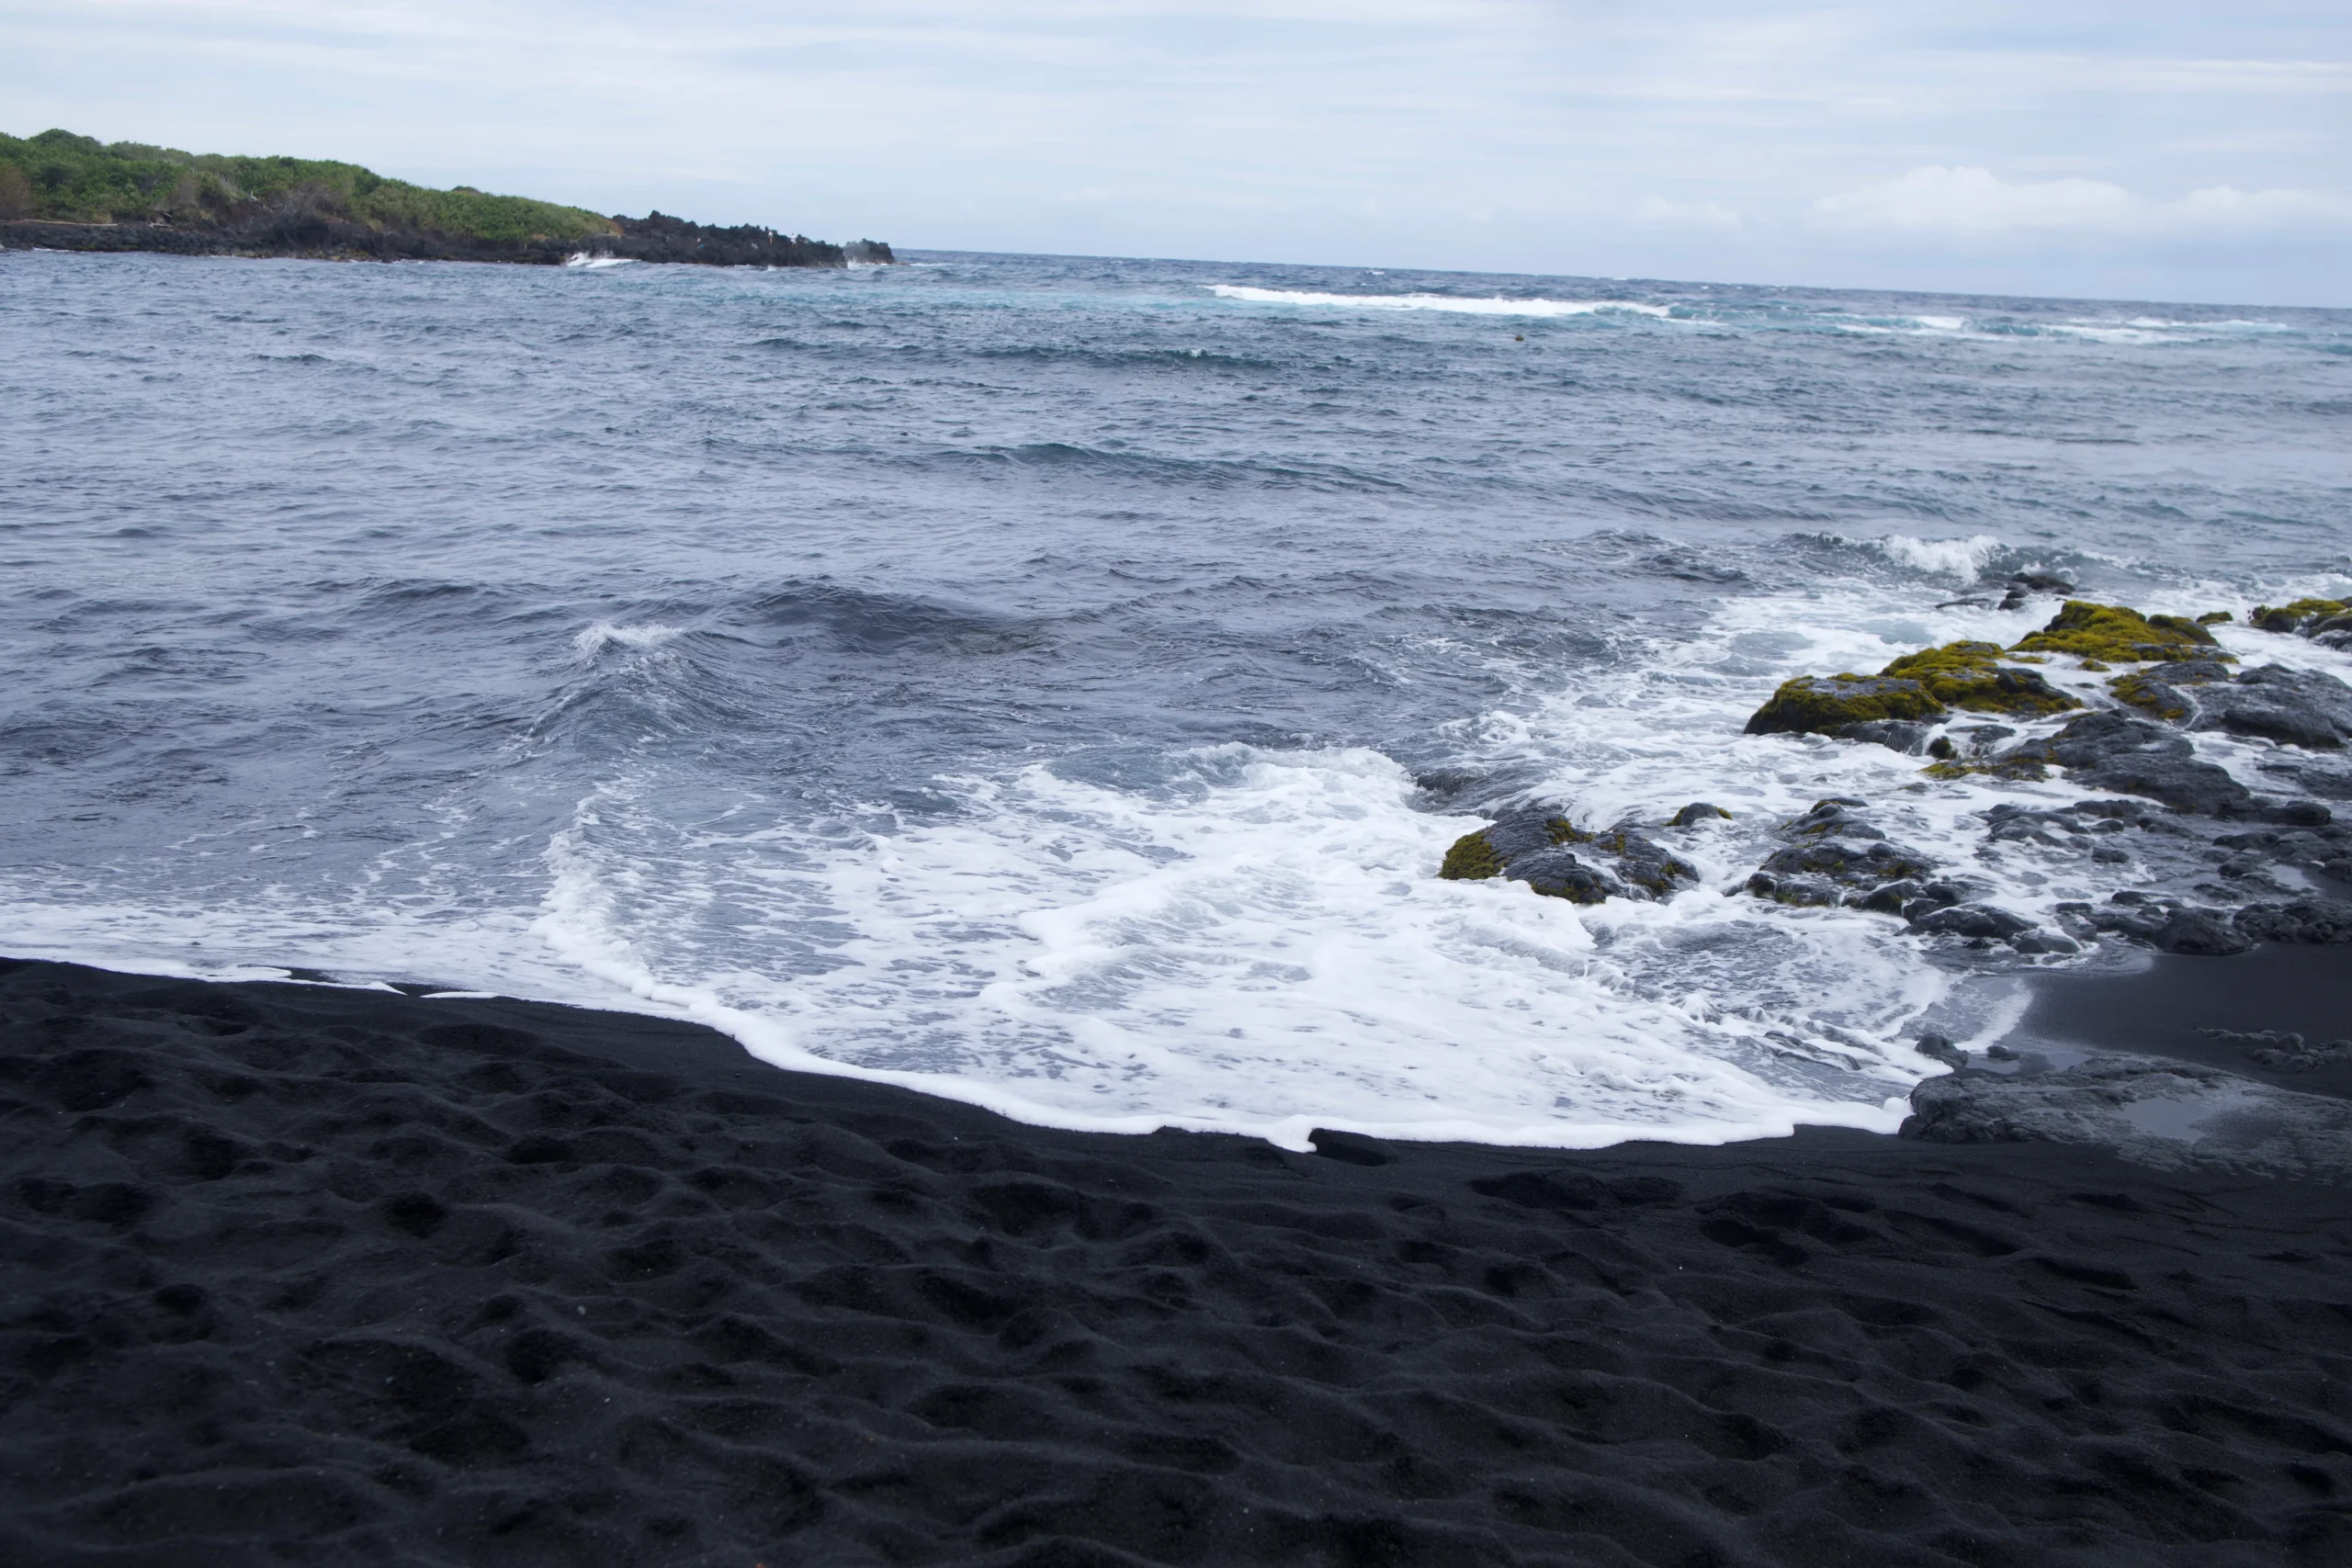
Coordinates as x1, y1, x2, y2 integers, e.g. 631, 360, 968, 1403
2011, 942, 2352, 1098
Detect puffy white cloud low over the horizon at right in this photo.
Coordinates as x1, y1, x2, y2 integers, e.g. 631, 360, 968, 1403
1814, 164, 2345, 237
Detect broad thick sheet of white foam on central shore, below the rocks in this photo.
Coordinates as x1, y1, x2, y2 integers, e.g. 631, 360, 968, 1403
538, 748, 1940, 1147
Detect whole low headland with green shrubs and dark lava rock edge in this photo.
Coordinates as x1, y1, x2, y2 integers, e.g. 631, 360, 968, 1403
0, 130, 894, 268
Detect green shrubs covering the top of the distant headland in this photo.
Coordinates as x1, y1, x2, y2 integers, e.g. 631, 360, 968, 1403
0, 131, 614, 244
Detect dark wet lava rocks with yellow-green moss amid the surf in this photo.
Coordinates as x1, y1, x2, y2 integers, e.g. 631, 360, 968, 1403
1440, 573, 2352, 957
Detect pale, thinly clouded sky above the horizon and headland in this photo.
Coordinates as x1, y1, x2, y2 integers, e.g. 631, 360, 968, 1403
0, 0, 2352, 306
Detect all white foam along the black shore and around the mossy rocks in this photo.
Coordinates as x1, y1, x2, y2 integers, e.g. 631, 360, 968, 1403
14, 552, 2352, 1147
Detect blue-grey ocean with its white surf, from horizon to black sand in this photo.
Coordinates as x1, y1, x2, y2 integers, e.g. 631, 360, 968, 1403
0, 252, 2352, 1147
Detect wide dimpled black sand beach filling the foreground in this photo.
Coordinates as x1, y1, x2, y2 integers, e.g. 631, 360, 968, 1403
0, 964, 2352, 1568
